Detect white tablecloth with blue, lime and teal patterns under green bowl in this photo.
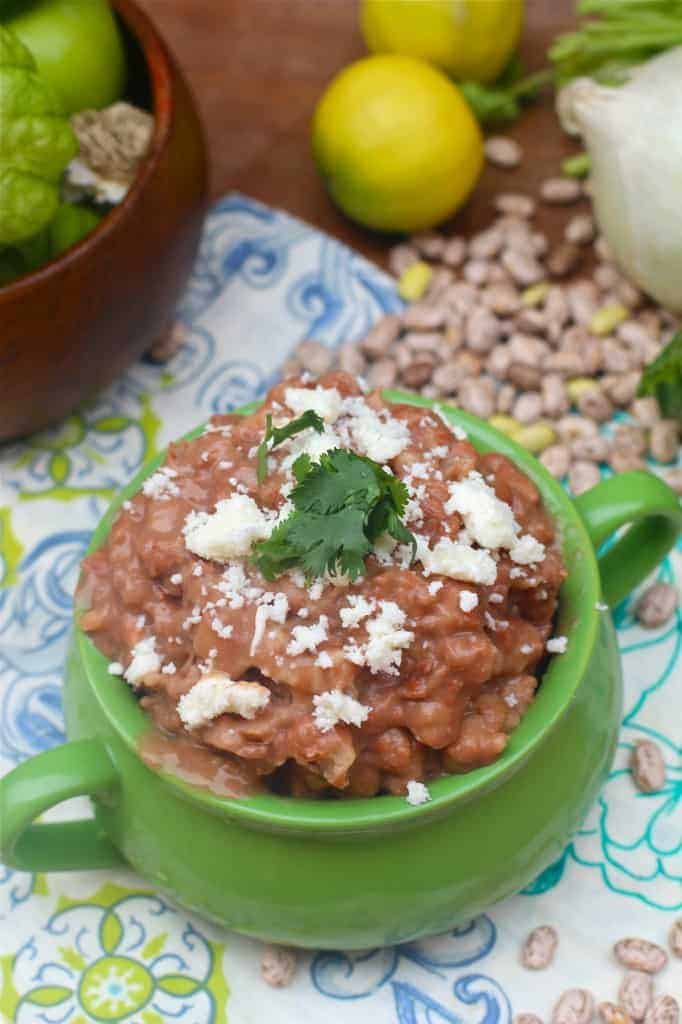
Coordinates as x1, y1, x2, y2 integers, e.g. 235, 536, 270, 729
0, 196, 682, 1024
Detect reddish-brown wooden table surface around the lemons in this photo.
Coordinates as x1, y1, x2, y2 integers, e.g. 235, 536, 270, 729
140, 0, 576, 264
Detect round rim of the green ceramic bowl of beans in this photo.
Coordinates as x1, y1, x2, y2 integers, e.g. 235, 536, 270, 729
75, 390, 602, 836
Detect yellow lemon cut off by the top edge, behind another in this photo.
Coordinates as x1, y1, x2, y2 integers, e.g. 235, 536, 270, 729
360, 0, 523, 82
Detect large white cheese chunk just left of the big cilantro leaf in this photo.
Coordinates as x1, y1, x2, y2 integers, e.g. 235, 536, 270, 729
182, 495, 272, 562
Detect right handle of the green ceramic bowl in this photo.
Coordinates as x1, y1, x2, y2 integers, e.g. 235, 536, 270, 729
576, 470, 682, 607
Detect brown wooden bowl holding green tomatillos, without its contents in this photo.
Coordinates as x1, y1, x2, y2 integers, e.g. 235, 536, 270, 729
0, 0, 207, 440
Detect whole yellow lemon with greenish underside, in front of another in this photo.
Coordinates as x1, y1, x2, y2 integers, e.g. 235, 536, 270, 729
312, 54, 483, 231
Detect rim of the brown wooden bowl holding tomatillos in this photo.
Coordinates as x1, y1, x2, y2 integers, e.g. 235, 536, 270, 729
0, 0, 173, 303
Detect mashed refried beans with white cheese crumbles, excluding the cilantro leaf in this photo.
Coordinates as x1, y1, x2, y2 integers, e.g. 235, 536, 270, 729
78, 373, 566, 804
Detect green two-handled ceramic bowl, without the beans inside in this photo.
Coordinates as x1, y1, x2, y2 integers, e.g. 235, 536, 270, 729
0, 392, 682, 948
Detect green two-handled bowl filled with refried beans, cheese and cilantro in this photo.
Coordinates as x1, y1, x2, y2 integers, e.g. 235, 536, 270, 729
0, 375, 682, 948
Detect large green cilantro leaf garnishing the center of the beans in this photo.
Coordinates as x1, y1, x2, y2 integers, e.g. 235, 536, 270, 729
253, 448, 417, 581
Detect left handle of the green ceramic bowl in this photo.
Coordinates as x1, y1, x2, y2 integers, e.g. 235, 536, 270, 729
0, 739, 124, 871
